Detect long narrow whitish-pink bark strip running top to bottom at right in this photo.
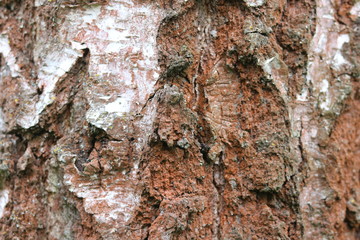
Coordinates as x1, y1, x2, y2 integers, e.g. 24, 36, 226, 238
300, 0, 351, 239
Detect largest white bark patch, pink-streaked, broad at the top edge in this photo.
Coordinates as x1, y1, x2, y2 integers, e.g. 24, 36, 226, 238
61, 0, 164, 131
